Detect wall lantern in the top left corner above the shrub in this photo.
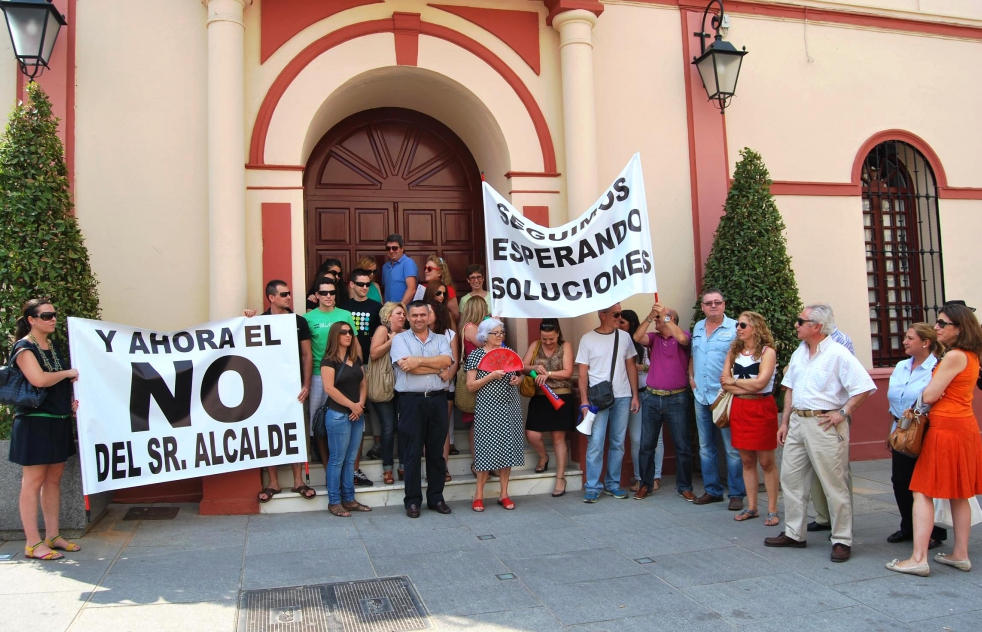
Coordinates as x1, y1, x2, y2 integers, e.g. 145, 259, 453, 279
0, 0, 68, 80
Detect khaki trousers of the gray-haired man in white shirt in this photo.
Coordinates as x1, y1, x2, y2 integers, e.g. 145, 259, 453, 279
781, 412, 852, 546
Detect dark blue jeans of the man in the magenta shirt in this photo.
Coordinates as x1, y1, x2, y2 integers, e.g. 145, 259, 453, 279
638, 391, 692, 492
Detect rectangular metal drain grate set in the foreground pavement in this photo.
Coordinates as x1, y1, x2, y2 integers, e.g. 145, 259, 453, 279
237, 577, 430, 632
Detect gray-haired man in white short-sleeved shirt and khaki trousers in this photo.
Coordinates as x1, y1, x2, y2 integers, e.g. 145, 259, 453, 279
764, 303, 876, 562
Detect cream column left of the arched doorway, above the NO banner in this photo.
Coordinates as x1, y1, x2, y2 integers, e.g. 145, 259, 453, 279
202, 0, 252, 320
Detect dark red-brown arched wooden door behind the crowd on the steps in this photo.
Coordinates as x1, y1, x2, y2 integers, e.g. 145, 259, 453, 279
304, 108, 484, 292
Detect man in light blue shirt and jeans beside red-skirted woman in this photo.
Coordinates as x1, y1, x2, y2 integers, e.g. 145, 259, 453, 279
689, 288, 744, 511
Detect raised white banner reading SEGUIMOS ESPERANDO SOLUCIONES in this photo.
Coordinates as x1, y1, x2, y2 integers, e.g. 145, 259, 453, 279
484, 154, 657, 318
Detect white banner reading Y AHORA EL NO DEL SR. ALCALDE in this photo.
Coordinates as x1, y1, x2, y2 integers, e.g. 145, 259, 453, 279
68, 314, 307, 494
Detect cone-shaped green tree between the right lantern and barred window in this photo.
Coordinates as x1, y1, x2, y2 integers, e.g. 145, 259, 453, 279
695, 148, 801, 366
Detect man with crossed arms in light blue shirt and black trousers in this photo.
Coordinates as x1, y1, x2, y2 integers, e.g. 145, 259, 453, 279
389, 301, 453, 518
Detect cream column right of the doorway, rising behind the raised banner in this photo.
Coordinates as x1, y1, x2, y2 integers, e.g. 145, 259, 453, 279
552, 9, 600, 219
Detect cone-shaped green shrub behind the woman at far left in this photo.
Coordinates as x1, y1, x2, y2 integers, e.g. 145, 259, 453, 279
0, 82, 99, 438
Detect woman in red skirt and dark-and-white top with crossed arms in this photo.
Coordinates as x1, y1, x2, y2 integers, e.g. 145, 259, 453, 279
720, 312, 781, 527
